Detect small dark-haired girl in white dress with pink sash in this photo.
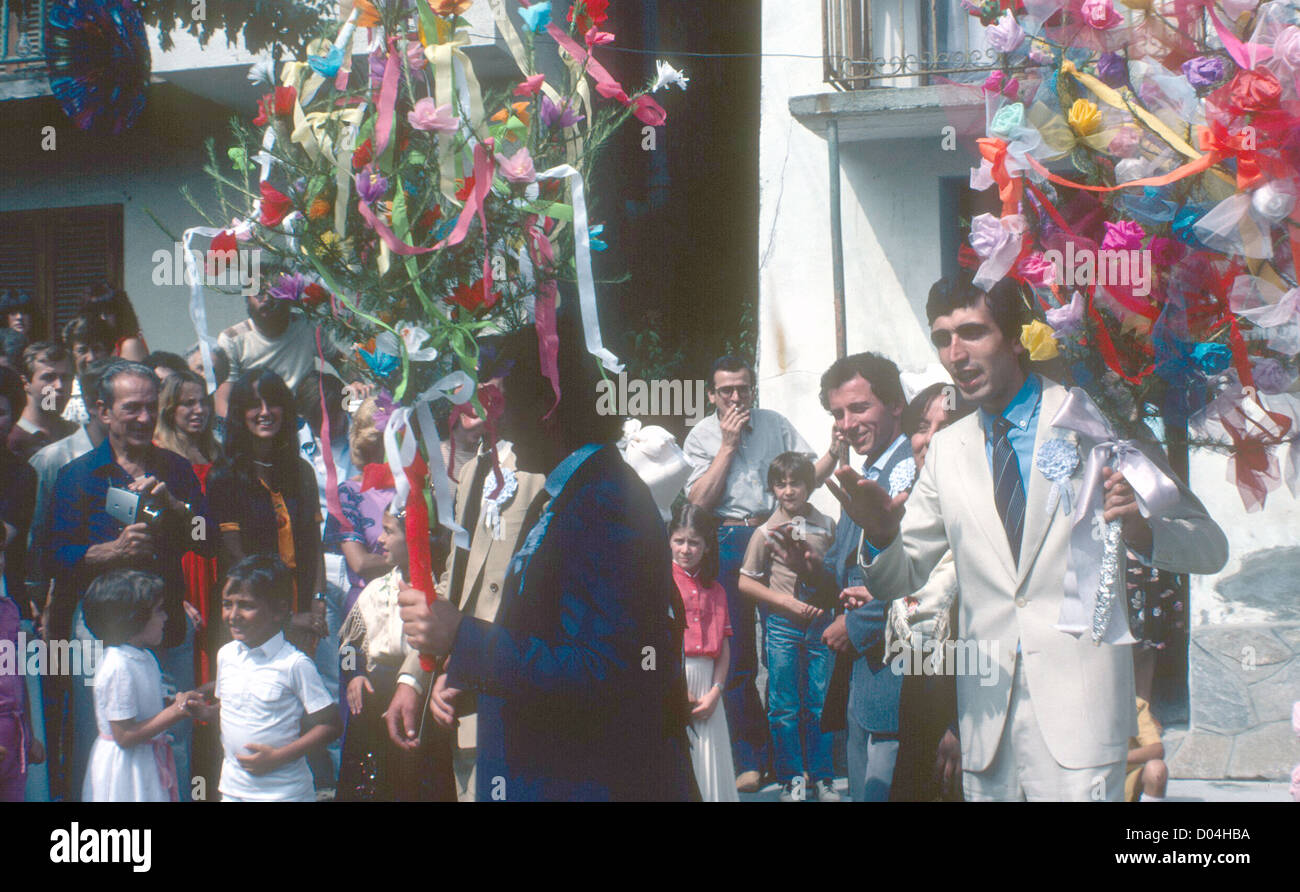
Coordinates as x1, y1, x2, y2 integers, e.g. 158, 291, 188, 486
82, 570, 202, 802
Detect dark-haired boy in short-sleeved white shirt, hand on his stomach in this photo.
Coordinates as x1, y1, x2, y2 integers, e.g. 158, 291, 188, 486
194, 554, 342, 802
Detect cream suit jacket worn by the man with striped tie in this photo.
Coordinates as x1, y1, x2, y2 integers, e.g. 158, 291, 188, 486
863, 380, 1227, 771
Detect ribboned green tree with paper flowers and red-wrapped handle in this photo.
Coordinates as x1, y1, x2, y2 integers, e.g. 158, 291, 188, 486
172, 0, 686, 657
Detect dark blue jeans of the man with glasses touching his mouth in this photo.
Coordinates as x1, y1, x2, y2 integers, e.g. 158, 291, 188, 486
718, 527, 768, 774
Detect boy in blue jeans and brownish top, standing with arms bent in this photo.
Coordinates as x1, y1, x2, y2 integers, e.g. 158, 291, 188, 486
740, 453, 840, 802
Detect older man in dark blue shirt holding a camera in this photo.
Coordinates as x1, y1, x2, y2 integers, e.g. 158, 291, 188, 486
51, 360, 215, 797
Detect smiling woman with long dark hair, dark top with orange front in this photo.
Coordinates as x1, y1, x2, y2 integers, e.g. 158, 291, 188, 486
208, 369, 326, 657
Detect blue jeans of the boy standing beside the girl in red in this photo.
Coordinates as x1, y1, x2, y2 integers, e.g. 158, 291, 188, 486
766, 614, 835, 783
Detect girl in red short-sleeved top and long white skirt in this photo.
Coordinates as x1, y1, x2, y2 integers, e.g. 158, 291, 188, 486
668, 502, 740, 802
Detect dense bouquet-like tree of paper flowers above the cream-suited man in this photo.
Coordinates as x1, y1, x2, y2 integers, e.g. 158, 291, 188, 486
962, 0, 1300, 510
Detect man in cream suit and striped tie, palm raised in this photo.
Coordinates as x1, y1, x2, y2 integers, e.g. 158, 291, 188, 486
832, 277, 1227, 801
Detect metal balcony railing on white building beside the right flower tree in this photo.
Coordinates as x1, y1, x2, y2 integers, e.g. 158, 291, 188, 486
822, 0, 997, 90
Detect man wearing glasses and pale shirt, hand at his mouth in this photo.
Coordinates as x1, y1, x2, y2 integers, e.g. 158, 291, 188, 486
684, 356, 836, 793
